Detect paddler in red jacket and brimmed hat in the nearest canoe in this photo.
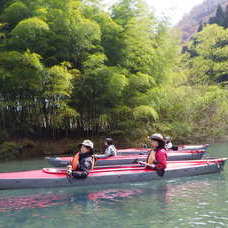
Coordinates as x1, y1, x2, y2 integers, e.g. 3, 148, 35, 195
146, 134, 167, 171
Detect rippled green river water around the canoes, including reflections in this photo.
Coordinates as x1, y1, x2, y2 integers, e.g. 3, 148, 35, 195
0, 144, 228, 228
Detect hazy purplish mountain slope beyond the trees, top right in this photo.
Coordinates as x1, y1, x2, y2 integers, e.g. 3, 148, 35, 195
177, 0, 228, 42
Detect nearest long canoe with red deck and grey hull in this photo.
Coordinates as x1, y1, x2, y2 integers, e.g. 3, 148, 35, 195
0, 158, 227, 189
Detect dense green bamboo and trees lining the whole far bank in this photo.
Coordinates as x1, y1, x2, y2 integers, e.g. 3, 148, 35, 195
0, 0, 228, 140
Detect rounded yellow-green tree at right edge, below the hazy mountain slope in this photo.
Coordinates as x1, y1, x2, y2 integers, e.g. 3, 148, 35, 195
188, 24, 228, 84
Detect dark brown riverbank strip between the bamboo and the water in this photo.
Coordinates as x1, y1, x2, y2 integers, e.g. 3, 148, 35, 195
0, 136, 228, 161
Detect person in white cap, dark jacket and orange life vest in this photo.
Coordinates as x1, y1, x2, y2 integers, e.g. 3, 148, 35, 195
67, 140, 94, 178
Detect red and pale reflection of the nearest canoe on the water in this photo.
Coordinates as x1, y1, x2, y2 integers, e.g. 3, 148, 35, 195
0, 176, 223, 213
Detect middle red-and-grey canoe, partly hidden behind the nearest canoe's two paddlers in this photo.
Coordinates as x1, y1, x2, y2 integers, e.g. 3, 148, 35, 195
46, 151, 206, 167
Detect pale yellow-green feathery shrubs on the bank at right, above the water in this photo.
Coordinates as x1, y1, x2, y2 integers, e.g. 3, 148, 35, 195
150, 86, 228, 142
